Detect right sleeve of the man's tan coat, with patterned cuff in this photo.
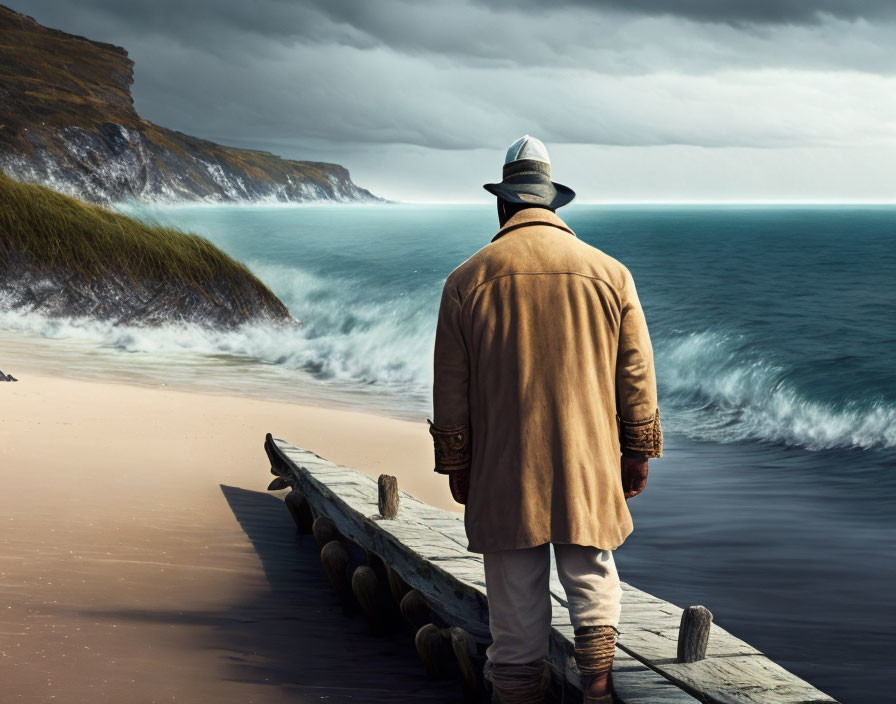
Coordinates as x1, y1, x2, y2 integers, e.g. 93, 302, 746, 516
616, 270, 663, 457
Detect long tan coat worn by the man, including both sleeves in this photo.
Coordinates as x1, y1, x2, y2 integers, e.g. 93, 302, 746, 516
431, 208, 662, 552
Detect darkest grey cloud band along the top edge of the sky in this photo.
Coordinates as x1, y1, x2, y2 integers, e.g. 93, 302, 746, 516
11, 0, 896, 74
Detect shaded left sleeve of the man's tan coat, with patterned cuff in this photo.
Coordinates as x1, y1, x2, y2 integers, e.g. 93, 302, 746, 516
429, 279, 471, 474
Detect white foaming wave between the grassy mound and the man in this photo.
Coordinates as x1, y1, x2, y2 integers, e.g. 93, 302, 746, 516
0, 265, 437, 407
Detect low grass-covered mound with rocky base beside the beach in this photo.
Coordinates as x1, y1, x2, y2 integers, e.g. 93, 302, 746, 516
0, 173, 293, 328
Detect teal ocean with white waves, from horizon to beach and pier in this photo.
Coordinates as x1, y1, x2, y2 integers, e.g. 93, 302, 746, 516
0, 204, 896, 703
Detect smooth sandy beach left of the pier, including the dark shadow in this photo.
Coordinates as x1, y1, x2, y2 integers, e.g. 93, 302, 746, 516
0, 367, 459, 703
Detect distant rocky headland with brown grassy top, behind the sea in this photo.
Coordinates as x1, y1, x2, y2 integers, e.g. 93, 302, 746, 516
0, 6, 381, 202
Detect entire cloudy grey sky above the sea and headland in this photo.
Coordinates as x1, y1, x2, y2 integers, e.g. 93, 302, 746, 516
12, 0, 896, 202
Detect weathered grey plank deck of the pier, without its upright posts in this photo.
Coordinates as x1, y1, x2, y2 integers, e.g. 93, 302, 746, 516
274, 440, 834, 704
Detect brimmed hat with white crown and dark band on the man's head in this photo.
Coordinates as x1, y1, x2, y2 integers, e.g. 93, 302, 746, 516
483, 134, 576, 210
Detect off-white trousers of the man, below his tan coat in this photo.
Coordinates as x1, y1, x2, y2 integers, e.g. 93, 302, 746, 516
483, 543, 622, 665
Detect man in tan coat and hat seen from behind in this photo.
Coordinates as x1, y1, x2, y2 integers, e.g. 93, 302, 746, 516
430, 135, 662, 704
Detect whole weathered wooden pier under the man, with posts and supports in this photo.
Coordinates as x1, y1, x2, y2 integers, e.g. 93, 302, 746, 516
265, 435, 835, 704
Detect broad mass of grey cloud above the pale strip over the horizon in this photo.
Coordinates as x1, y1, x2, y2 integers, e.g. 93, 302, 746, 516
11, 0, 896, 159
